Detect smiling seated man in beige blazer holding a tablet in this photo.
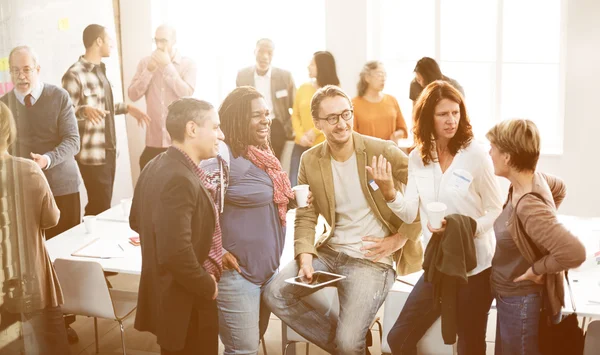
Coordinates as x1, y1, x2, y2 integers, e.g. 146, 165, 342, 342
264, 85, 423, 355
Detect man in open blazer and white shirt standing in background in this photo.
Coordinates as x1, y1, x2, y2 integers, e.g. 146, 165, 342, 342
235, 38, 296, 161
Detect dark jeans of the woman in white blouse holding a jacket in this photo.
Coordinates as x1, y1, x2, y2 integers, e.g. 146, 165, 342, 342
387, 268, 493, 355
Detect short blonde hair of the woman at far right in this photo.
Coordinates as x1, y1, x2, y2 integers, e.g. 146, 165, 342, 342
485, 119, 541, 171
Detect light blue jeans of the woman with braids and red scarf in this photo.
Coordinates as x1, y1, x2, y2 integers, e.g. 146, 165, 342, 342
217, 270, 273, 355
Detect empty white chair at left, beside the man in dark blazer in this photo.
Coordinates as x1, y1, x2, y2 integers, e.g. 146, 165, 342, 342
54, 259, 137, 355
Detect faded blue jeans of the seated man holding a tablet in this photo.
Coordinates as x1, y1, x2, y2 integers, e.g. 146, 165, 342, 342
263, 245, 396, 355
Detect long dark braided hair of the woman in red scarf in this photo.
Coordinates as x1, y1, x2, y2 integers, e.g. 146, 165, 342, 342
219, 86, 270, 158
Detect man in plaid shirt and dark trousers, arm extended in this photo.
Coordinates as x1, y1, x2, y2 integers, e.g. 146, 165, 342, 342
62, 24, 150, 215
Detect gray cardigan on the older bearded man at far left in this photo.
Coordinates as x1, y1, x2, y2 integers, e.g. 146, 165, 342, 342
0, 84, 80, 196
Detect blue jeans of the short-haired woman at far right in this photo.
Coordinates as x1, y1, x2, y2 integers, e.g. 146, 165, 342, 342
495, 293, 542, 355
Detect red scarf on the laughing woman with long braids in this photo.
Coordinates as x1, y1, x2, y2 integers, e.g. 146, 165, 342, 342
246, 145, 294, 227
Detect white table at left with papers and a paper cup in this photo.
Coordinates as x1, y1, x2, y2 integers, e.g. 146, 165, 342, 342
46, 205, 142, 275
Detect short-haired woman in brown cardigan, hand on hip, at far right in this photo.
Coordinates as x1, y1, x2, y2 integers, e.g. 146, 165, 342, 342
486, 119, 585, 355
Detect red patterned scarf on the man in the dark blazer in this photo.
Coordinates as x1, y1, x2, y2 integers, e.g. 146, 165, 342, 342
174, 147, 223, 282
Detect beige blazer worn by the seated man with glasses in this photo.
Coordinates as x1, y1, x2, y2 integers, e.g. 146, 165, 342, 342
294, 132, 423, 275
